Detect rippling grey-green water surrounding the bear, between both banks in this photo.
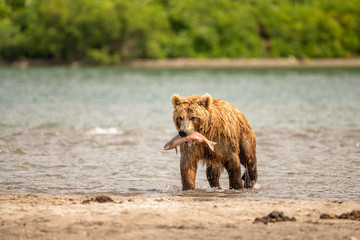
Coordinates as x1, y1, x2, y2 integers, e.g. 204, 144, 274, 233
0, 67, 360, 201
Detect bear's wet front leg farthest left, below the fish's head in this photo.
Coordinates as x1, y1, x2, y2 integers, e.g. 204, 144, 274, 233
180, 154, 197, 191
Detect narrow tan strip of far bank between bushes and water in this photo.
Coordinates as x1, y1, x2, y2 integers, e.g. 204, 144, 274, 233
0, 58, 360, 68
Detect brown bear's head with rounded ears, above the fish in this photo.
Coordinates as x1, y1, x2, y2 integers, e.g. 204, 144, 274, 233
171, 94, 213, 137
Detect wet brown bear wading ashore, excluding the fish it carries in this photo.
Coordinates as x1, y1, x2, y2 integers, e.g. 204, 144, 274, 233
171, 94, 257, 190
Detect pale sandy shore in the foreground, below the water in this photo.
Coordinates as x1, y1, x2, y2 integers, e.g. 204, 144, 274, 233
0, 194, 360, 240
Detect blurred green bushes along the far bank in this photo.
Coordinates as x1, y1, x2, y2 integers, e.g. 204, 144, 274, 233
0, 0, 360, 64
